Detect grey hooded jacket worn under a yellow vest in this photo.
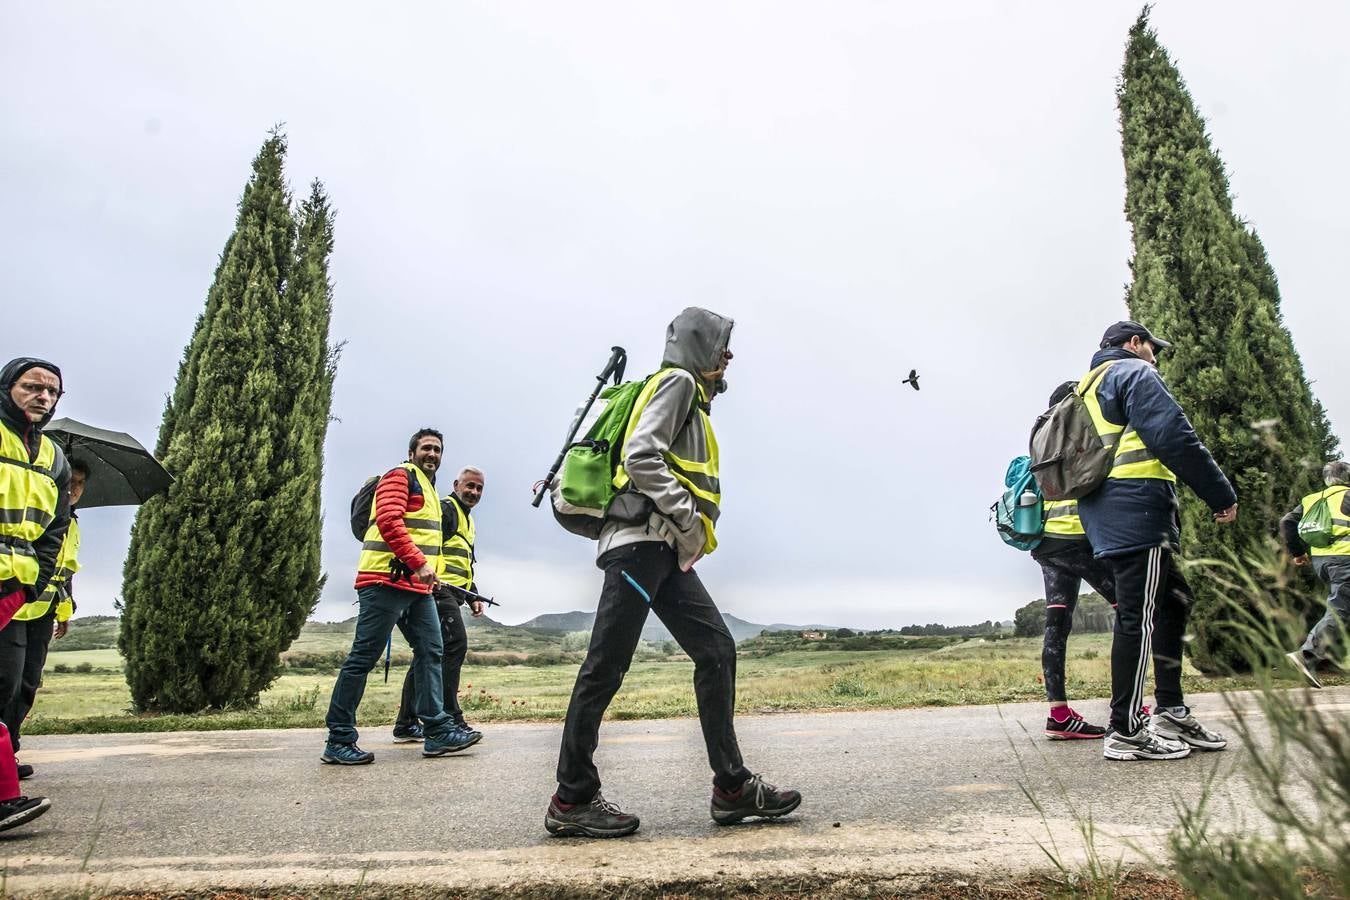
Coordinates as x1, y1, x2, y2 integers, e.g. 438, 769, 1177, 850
597, 306, 736, 565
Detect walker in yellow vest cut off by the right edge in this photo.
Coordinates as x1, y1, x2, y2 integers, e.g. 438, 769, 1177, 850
1280, 460, 1350, 688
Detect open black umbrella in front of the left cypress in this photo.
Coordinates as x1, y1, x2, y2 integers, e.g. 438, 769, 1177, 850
42, 418, 173, 509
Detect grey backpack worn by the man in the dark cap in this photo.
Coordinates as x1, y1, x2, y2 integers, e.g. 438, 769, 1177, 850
1031, 360, 1116, 501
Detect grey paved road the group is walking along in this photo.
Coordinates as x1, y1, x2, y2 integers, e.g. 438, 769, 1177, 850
0, 688, 1350, 892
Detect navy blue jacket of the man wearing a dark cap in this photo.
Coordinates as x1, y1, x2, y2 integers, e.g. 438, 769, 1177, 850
1079, 347, 1238, 557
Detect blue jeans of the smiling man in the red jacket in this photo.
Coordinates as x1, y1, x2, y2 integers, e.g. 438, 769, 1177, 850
325, 584, 450, 743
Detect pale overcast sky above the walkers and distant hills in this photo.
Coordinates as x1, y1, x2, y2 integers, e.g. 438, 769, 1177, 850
0, 0, 1350, 627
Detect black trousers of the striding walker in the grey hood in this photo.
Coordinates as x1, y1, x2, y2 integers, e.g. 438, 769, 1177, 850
558, 541, 751, 803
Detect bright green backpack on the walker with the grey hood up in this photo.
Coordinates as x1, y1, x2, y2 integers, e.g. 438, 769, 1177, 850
549, 376, 649, 540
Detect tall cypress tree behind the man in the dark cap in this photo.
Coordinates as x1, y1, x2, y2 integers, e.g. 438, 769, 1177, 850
1116, 7, 1337, 671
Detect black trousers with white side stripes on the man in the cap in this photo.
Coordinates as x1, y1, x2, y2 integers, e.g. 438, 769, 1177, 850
1106, 546, 1195, 734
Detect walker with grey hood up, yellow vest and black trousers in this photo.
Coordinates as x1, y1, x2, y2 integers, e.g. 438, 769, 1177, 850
544, 308, 802, 838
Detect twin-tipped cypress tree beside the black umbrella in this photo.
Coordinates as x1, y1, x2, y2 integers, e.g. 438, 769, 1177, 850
117, 132, 336, 712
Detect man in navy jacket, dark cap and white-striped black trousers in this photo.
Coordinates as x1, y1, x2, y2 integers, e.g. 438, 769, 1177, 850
1079, 322, 1238, 760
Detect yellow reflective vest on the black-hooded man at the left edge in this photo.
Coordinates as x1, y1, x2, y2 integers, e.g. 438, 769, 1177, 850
0, 425, 61, 586
